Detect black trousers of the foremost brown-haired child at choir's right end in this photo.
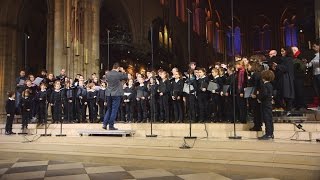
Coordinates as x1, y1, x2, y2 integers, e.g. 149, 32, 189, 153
261, 102, 274, 136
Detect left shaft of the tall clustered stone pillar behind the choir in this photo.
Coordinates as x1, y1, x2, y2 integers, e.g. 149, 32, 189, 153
53, 0, 66, 75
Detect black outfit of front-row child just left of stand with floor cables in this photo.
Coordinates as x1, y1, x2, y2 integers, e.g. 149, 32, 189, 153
171, 79, 184, 122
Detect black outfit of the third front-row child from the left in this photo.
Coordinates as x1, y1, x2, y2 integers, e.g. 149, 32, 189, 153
36, 90, 48, 124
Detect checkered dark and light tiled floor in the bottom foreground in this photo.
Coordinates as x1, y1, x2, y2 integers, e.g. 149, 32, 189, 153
0, 159, 273, 180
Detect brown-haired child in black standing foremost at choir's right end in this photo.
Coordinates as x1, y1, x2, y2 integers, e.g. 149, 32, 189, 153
257, 70, 274, 140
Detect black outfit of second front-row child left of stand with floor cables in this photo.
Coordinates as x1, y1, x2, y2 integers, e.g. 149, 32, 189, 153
158, 80, 170, 122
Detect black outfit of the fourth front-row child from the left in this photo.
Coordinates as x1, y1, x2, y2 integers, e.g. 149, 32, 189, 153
50, 90, 65, 123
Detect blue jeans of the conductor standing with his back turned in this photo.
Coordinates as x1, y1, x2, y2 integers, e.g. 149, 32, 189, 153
103, 96, 121, 128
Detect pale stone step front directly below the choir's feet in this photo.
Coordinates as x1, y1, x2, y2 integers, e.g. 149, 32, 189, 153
0, 122, 320, 141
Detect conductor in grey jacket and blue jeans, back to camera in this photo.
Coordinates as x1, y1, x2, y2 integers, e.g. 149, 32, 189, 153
102, 63, 130, 130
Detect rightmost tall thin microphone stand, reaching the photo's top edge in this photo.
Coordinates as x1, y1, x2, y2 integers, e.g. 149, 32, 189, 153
229, 0, 242, 139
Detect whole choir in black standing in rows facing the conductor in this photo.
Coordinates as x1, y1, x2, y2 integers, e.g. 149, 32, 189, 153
6, 39, 320, 138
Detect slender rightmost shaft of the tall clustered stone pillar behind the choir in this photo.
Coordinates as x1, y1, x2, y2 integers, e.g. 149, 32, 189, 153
89, 0, 100, 76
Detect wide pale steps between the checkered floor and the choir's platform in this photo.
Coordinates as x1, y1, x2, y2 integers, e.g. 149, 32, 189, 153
0, 135, 320, 180
